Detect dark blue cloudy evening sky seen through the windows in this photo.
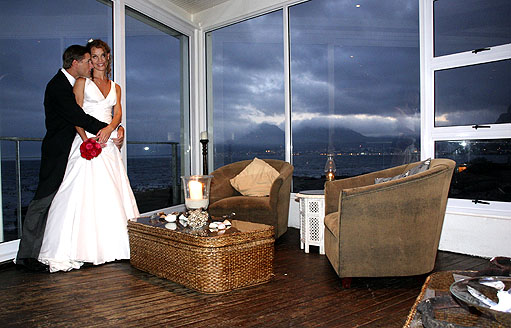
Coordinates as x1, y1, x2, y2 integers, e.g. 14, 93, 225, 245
0, 0, 511, 159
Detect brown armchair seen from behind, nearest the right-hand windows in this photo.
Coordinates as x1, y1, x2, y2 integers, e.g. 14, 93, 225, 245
325, 159, 456, 286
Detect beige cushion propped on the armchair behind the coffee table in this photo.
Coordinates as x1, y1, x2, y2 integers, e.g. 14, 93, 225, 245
230, 157, 279, 197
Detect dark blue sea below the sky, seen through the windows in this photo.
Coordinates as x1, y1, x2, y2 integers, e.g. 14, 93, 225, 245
1, 152, 418, 241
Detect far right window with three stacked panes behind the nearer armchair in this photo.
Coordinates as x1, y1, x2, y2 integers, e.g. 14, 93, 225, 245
432, 0, 511, 204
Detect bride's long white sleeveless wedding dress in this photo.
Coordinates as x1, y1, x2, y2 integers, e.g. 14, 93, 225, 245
39, 79, 139, 272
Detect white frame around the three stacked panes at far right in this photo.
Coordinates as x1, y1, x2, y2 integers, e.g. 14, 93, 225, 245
419, 0, 511, 217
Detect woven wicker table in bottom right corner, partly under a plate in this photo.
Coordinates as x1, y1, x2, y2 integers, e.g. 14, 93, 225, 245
403, 271, 505, 328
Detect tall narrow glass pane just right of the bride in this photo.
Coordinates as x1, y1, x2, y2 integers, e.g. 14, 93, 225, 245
125, 8, 189, 213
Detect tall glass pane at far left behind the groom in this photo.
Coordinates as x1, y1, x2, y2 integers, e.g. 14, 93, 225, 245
0, 0, 112, 242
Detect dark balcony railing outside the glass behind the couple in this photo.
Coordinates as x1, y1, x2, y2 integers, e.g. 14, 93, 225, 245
0, 137, 179, 242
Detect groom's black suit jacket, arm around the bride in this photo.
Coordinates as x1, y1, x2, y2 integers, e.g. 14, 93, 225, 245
34, 70, 107, 199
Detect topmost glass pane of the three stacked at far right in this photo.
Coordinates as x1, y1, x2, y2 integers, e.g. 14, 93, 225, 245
433, 0, 511, 56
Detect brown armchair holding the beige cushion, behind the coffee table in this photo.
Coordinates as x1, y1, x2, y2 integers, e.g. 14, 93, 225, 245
208, 159, 293, 238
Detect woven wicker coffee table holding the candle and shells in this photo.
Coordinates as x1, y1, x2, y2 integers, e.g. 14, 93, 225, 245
128, 218, 274, 294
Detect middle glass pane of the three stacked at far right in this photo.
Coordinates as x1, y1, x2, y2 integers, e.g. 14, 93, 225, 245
435, 60, 511, 127
